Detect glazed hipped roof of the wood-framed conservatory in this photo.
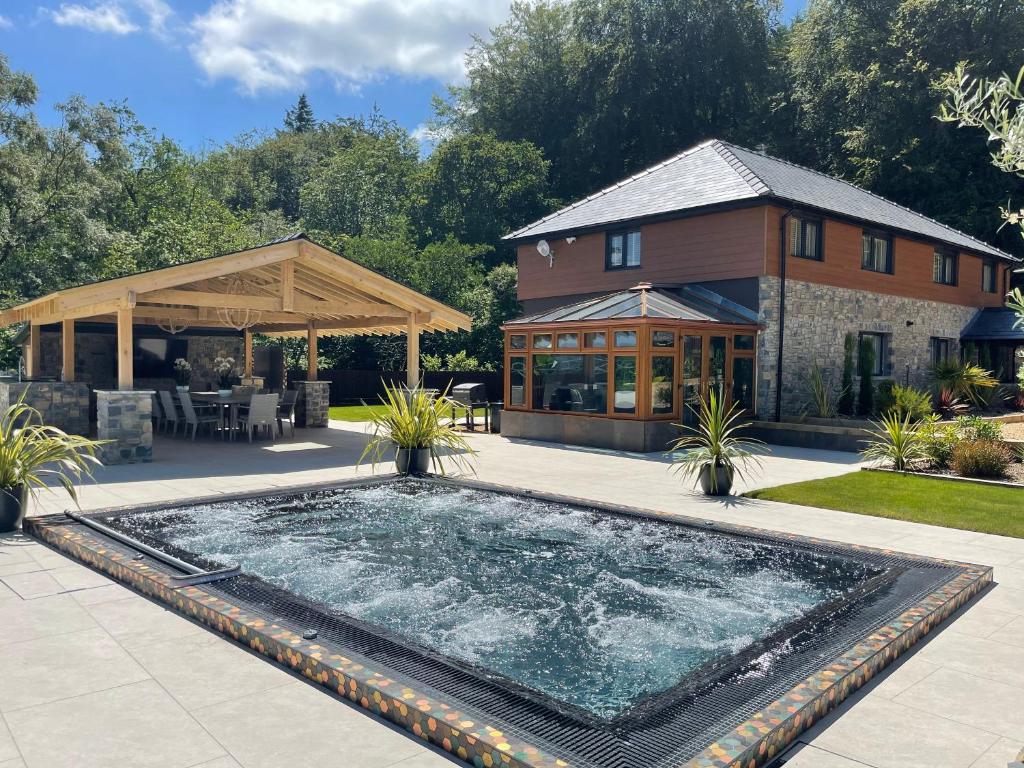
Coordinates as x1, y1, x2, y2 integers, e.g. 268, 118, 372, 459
505, 285, 758, 326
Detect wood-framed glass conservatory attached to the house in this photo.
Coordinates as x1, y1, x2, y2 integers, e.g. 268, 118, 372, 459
502, 284, 759, 451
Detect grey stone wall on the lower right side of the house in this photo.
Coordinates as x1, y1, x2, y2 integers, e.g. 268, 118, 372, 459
758, 276, 978, 418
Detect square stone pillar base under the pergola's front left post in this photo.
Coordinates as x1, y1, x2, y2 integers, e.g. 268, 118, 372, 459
96, 390, 154, 464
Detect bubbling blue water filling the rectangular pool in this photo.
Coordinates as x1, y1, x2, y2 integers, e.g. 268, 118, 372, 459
118, 480, 873, 718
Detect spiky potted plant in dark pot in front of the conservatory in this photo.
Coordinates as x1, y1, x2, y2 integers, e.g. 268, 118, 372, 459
670, 388, 765, 496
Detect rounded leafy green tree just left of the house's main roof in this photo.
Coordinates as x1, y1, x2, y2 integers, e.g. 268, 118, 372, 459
417, 133, 551, 260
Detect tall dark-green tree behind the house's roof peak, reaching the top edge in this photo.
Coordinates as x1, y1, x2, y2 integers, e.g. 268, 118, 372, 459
446, 0, 778, 200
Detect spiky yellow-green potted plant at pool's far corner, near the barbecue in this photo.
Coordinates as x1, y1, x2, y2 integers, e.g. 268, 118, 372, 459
359, 383, 475, 475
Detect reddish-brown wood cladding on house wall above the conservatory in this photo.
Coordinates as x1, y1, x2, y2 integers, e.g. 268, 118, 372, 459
518, 208, 765, 300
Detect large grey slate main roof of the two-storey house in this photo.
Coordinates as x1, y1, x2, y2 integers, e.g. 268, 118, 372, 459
505, 139, 1019, 261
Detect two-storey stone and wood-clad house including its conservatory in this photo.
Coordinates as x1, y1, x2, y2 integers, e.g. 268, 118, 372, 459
503, 140, 1024, 451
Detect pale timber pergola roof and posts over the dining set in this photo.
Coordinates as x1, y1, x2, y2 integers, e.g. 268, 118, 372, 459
0, 233, 470, 390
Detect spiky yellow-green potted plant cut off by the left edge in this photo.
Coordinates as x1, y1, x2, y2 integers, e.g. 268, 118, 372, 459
0, 400, 100, 534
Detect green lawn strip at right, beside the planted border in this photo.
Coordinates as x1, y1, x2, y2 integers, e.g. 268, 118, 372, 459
745, 471, 1024, 538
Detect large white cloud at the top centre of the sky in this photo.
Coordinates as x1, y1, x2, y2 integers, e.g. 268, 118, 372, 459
190, 0, 509, 92
